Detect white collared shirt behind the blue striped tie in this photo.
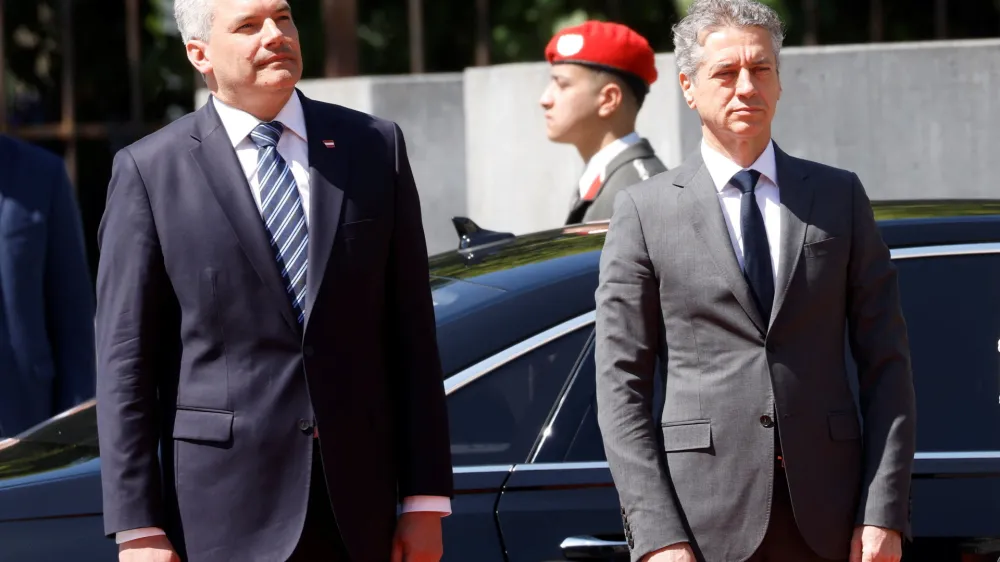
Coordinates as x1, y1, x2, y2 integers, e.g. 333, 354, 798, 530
212, 94, 309, 227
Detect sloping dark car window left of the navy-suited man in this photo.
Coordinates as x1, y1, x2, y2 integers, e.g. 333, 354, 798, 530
0, 402, 99, 480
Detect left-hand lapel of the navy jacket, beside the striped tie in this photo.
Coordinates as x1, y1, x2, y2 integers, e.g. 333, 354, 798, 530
191, 99, 299, 331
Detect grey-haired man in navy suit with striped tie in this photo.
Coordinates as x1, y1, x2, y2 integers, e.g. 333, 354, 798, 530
97, 0, 452, 562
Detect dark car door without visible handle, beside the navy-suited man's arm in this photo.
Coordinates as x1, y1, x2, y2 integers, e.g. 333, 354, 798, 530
442, 312, 591, 562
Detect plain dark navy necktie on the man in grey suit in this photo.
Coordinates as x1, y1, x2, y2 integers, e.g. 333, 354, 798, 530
730, 170, 774, 324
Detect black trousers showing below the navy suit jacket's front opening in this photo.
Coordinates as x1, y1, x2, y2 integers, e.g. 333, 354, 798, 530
288, 439, 351, 562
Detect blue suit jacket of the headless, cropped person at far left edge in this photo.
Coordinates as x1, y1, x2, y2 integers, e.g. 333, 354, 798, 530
0, 136, 95, 437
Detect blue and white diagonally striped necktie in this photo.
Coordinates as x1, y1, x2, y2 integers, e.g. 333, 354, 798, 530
250, 121, 309, 325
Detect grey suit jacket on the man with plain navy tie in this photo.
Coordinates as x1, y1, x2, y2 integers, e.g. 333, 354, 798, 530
596, 146, 915, 562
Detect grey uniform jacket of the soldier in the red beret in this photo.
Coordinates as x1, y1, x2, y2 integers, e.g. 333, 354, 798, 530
566, 139, 667, 224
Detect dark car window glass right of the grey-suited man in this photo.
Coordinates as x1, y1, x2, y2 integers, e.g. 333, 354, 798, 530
896, 254, 1000, 452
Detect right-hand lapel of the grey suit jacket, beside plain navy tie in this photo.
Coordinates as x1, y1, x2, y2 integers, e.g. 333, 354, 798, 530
771, 143, 814, 324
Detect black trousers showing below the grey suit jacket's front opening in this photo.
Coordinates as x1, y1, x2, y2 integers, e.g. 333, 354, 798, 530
747, 449, 847, 562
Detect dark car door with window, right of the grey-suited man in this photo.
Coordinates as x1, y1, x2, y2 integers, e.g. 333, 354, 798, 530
893, 247, 1000, 540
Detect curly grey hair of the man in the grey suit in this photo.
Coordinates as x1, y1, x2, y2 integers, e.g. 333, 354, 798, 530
673, 0, 785, 80
